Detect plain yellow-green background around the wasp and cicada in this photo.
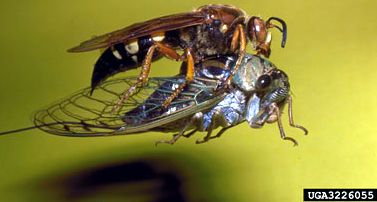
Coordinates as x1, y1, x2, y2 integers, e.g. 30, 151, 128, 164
0, 0, 377, 202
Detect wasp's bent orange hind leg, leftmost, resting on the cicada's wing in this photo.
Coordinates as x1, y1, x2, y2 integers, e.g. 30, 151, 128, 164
112, 42, 181, 113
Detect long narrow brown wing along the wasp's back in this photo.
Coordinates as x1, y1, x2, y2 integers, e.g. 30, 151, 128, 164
68, 12, 205, 52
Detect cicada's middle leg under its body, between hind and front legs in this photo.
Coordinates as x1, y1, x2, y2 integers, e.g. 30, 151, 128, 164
196, 111, 230, 144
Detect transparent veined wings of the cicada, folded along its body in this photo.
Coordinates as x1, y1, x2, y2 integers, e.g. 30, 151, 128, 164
34, 77, 223, 136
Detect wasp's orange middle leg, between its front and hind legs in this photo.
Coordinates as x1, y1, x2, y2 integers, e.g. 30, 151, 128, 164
162, 49, 194, 108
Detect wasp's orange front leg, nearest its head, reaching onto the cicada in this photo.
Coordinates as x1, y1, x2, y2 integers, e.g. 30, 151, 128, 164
219, 24, 246, 86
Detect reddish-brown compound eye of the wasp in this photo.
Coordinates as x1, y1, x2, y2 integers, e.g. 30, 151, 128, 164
248, 16, 268, 48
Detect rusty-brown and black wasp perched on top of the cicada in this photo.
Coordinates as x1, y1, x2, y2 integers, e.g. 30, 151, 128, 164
68, 5, 287, 110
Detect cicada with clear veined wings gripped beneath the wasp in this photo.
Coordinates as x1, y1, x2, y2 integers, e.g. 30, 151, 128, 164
2, 54, 308, 145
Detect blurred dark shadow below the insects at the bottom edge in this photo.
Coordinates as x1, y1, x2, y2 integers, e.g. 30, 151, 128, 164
43, 160, 189, 202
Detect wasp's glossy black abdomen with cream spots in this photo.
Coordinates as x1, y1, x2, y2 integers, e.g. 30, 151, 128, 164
91, 36, 160, 90
